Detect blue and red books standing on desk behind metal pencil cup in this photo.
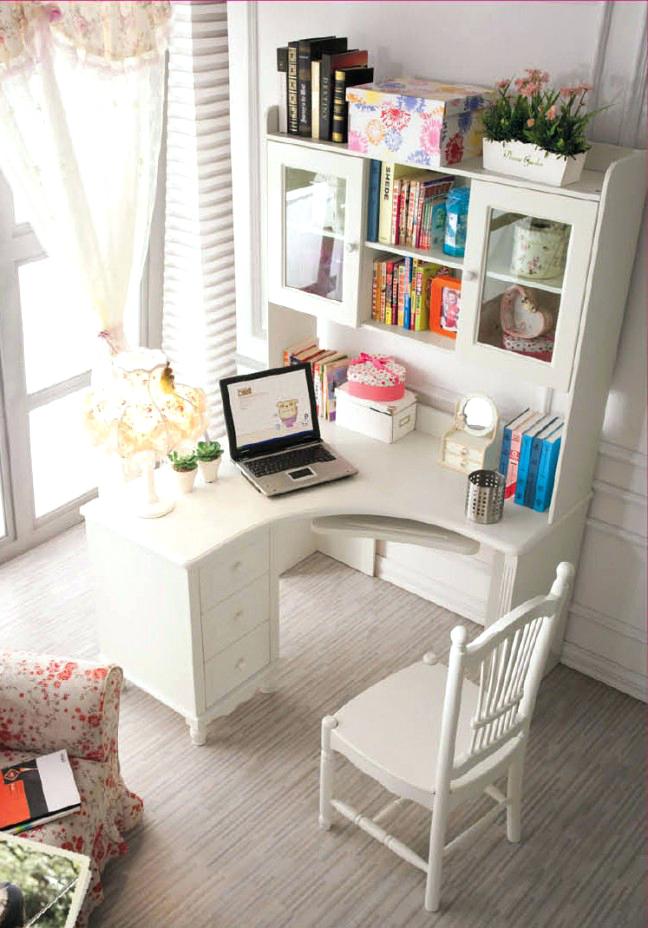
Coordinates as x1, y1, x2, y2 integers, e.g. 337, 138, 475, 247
499, 409, 564, 512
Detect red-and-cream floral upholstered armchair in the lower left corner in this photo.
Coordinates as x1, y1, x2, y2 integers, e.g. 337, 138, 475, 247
0, 651, 143, 926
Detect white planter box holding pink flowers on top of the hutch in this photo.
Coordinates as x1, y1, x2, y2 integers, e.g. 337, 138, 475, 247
483, 139, 585, 187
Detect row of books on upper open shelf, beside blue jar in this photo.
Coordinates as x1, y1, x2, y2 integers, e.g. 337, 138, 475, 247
367, 161, 453, 251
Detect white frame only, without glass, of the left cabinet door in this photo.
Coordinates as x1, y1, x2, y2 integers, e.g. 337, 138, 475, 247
267, 141, 366, 327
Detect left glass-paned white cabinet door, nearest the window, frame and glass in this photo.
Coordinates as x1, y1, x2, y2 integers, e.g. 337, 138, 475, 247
268, 142, 364, 325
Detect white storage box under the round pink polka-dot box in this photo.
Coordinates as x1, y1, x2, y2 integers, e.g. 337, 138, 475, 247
335, 383, 416, 444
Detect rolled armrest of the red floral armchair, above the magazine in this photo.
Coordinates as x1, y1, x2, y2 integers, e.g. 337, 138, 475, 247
0, 651, 123, 761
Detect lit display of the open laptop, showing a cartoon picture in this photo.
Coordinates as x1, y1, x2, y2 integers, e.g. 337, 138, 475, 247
227, 370, 313, 450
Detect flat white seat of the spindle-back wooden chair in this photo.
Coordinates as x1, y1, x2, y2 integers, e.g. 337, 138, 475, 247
331, 661, 479, 807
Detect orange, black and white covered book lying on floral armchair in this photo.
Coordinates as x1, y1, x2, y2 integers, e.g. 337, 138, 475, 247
0, 751, 81, 833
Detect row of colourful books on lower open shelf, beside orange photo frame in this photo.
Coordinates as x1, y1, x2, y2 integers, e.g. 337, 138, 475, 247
371, 257, 451, 332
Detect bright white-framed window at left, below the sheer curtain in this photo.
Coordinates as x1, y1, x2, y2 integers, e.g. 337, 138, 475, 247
0, 175, 145, 560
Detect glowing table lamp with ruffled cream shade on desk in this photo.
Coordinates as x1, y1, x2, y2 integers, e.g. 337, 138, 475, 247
85, 348, 207, 519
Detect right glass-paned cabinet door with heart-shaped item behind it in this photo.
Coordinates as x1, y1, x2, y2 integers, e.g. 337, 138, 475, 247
458, 182, 597, 390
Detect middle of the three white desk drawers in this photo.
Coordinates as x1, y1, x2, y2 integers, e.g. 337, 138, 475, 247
201, 574, 270, 661
